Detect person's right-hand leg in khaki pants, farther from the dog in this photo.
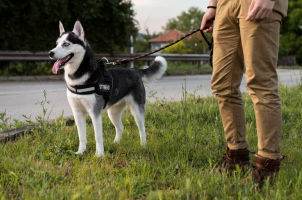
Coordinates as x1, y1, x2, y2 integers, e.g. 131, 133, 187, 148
239, 9, 282, 159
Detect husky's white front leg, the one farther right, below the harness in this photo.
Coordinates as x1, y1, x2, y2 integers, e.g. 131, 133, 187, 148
90, 113, 104, 157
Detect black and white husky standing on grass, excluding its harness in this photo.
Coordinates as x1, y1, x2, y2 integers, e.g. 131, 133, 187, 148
49, 21, 167, 157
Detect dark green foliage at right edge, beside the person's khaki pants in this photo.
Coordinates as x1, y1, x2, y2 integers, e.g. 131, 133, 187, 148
279, 0, 302, 65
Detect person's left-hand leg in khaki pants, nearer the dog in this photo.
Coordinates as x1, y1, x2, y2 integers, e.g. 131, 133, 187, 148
211, 0, 248, 150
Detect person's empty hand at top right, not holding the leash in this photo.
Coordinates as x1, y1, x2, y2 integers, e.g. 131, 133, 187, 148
245, 0, 275, 22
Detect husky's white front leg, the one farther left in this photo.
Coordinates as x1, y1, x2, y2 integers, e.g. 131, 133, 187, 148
72, 110, 87, 154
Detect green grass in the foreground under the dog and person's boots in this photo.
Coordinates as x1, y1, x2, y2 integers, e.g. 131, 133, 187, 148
0, 83, 302, 200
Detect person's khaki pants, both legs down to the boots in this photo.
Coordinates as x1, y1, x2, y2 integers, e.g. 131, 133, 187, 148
211, 0, 282, 159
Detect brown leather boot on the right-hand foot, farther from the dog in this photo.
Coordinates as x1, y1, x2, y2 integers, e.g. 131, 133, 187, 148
252, 154, 285, 188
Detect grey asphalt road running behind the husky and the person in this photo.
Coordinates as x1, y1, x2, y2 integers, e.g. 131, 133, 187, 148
0, 70, 302, 123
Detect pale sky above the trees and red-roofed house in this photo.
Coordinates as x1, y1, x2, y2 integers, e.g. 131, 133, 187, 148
131, 0, 209, 34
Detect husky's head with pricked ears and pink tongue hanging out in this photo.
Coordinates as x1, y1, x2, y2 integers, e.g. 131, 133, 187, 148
49, 21, 86, 74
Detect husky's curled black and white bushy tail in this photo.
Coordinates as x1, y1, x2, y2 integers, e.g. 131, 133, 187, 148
142, 56, 167, 84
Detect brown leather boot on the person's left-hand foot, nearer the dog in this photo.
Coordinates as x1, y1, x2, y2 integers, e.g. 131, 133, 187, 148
218, 147, 250, 173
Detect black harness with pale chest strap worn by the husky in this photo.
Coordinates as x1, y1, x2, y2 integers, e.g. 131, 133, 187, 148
67, 60, 113, 108
